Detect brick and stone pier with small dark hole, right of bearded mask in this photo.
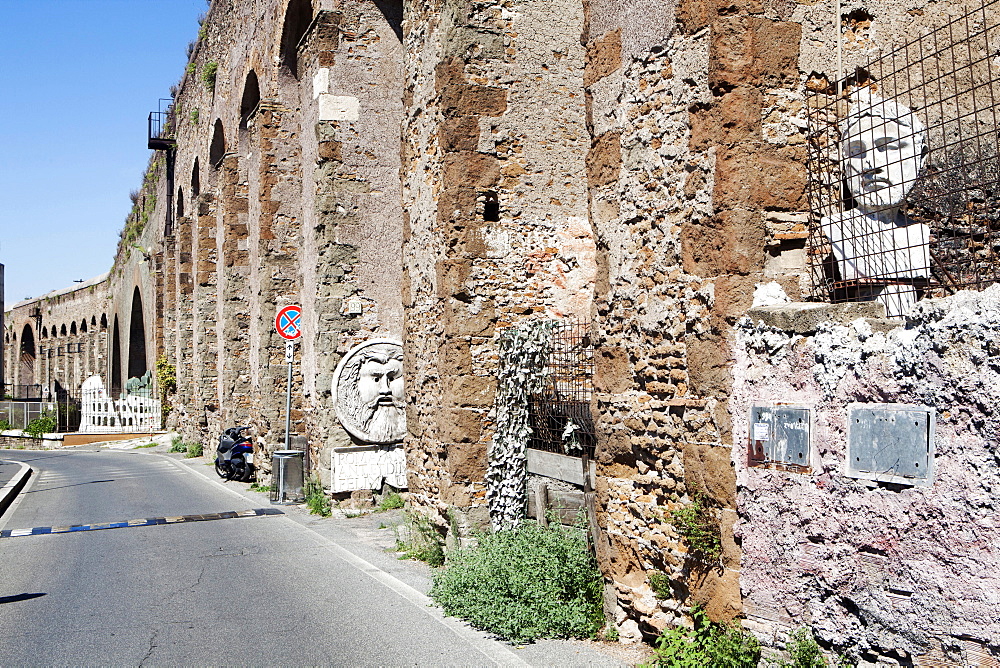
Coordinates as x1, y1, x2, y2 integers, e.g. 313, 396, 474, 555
402, 0, 594, 527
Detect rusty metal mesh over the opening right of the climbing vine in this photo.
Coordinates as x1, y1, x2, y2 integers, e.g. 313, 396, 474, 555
528, 321, 596, 458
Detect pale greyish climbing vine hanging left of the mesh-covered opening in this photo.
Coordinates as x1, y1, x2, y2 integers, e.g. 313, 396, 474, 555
486, 320, 555, 529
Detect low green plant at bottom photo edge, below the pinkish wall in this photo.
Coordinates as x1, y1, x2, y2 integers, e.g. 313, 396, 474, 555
653, 606, 760, 668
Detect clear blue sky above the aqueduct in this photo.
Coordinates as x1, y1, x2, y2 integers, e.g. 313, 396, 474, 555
0, 0, 208, 308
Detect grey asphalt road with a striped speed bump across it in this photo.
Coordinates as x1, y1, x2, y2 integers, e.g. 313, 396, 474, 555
0, 450, 613, 666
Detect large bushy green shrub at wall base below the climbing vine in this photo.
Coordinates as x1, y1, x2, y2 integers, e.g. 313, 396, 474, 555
431, 521, 604, 642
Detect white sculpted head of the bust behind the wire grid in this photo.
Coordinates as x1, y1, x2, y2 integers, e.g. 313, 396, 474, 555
843, 96, 924, 212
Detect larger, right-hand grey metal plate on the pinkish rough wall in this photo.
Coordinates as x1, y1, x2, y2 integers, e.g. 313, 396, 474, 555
845, 404, 934, 484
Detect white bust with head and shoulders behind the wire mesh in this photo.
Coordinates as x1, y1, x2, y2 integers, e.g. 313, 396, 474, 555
820, 92, 931, 317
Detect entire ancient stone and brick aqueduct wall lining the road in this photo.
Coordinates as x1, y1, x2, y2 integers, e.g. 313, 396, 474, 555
3, 0, 1000, 665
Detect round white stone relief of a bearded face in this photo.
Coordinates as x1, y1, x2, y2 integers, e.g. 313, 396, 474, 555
332, 339, 406, 445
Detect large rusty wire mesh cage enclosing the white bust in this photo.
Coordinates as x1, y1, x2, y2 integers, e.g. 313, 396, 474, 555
807, 0, 1000, 317
